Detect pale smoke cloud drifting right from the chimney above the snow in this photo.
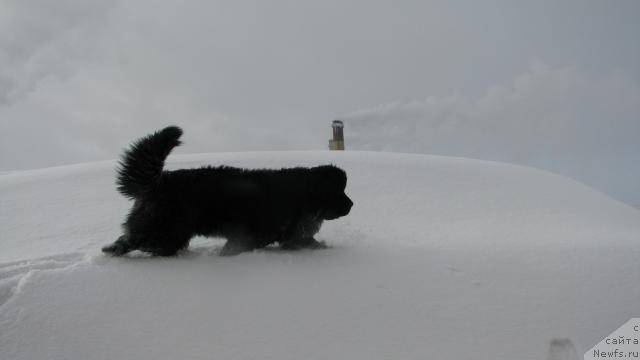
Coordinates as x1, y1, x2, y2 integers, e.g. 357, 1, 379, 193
343, 63, 640, 205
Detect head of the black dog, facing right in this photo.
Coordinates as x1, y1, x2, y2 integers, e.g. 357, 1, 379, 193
309, 165, 353, 220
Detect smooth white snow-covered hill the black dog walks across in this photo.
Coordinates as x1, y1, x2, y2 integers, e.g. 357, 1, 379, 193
0, 152, 640, 360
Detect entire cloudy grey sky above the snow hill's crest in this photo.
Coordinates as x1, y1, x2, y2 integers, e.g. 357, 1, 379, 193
0, 0, 640, 208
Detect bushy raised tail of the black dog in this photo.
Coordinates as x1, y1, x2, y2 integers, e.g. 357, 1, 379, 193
116, 126, 182, 199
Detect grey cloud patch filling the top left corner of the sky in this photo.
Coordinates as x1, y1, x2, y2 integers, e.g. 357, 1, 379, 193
0, 0, 114, 105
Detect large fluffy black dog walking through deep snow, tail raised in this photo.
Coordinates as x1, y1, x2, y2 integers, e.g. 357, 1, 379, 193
102, 126, 353, 256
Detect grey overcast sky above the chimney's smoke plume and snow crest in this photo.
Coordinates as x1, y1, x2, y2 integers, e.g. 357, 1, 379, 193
0, 0, 640, 171
